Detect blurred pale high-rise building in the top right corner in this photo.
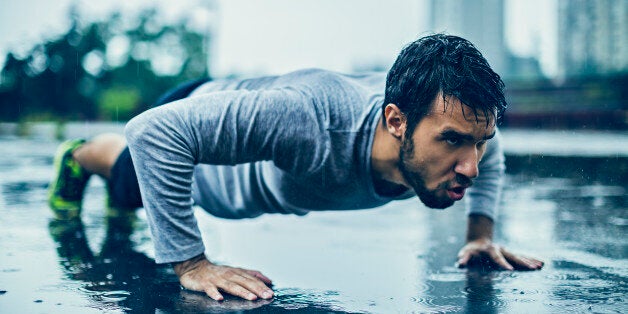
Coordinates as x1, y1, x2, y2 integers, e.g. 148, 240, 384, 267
558, 0, 628, 78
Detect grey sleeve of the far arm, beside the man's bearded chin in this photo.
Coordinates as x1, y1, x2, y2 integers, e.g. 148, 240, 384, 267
465, 130, 506, 221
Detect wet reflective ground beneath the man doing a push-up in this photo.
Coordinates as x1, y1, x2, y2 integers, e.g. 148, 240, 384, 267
0, 131, 628, 313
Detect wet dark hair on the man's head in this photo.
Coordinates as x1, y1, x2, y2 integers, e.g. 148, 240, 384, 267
382, 34, 506, 132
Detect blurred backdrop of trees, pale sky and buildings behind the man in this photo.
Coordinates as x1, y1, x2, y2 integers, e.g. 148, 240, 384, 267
0, 0, 628, 130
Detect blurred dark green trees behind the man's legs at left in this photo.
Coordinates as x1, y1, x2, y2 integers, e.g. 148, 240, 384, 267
0, 9, 209, 121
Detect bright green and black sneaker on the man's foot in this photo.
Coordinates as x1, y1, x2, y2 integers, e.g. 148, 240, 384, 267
48, 139, 90, 220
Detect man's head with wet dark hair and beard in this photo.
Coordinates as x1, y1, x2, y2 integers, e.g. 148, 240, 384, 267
383, 35, 506, 208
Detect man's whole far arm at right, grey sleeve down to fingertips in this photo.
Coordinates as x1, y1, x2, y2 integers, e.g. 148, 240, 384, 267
456, 133, 543, 270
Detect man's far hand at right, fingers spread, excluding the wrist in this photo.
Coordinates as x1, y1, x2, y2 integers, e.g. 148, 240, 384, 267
456, 238, 543, 270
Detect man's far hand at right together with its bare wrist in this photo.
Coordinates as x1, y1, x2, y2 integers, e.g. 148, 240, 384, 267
456, 214, 543, 270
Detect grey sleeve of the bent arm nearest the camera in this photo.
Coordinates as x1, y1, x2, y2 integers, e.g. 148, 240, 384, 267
125, 90, 325, 263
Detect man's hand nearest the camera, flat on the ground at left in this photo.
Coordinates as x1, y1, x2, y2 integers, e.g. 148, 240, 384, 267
174, 254, 274, 301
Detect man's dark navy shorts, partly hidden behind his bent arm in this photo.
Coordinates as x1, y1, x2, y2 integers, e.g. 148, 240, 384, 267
108, 78, 210, 208
